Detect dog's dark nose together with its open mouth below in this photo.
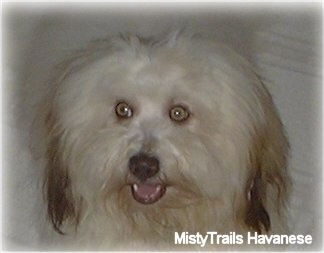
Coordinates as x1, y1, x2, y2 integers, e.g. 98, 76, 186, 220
129, 153, 166, 204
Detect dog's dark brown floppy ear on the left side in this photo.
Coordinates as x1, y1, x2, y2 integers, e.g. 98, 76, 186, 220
44, 108, 78, 234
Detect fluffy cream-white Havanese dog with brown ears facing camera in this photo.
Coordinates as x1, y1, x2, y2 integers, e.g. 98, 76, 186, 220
34, 33, 288, 249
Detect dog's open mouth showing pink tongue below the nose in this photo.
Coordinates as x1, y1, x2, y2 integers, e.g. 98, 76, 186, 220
132, 182, 166, 204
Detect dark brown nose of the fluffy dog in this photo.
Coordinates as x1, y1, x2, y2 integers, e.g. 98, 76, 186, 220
129, 153, 159, 181
